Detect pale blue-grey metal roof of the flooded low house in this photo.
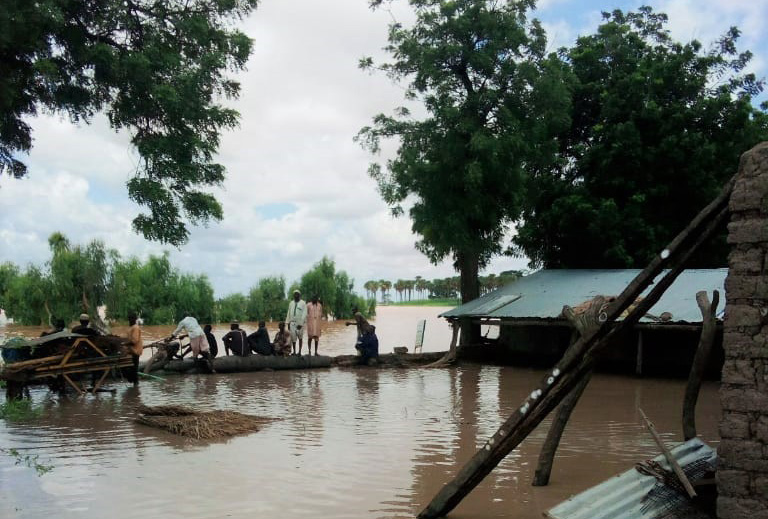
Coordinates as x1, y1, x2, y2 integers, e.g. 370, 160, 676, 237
440, 268, 728, 322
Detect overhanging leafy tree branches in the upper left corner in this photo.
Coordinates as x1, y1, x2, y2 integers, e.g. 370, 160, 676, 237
0, 0, 257, 245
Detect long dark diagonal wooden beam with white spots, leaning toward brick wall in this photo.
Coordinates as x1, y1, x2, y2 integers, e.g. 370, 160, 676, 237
418, 177, 735, 519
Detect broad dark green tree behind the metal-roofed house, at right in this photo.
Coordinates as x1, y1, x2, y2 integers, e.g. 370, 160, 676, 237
514, 7, 768, 268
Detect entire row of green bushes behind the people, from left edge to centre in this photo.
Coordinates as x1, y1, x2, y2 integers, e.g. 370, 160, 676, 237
0, 238, 376, 326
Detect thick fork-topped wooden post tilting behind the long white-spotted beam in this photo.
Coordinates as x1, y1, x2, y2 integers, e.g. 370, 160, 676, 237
531, 296, 606, 487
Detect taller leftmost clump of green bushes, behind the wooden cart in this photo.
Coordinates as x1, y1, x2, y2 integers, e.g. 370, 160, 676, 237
0, 233, 214, 325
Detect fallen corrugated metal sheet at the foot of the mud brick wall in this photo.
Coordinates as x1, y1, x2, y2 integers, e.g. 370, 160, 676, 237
546, 438, 717, 519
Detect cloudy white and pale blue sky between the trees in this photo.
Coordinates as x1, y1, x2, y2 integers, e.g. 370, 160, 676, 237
0, 0, 768, 297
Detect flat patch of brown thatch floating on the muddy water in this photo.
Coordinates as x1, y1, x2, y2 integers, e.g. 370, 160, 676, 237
136, 405, 273, 440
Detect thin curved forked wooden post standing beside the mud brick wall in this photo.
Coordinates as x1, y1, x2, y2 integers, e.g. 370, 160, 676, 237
683, 290, 720, 441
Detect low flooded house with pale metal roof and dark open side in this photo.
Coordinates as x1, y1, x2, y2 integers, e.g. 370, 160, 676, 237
441, 268, 728, 377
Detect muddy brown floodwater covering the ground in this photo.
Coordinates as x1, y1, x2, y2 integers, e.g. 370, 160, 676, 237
0, 308, 720, 519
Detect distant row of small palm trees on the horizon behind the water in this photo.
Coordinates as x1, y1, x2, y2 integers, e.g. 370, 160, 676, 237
363, 270, 523, 301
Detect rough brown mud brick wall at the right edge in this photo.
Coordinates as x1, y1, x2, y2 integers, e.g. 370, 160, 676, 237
717, 142, 768, 519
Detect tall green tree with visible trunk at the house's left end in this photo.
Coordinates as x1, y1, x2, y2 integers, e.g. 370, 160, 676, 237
357, 0, 568, 301
